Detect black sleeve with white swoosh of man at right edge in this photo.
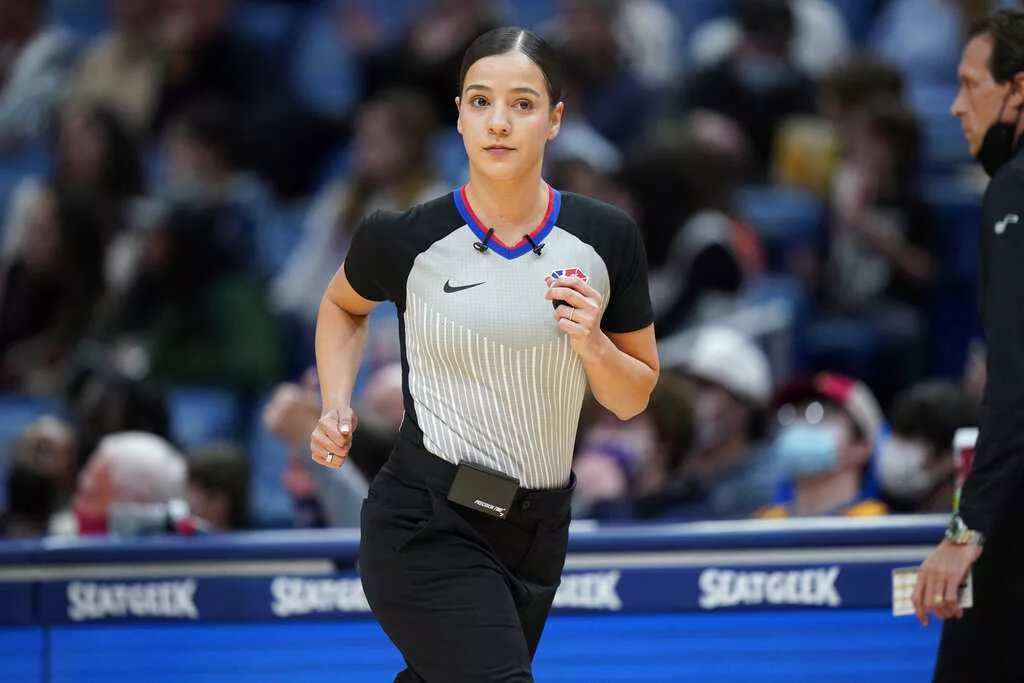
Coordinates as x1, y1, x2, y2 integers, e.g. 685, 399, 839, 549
961, 152, 1024, 536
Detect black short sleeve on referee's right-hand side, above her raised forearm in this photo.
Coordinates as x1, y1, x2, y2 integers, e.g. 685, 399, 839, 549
601, 214, 653, 333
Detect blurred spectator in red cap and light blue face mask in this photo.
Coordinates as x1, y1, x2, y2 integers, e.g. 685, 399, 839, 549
756, 373, 888, 519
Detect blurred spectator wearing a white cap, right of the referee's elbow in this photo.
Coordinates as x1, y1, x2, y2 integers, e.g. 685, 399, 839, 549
638, 326, 781, 518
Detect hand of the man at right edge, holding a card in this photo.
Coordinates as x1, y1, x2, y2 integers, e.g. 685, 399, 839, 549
912, 541, 981, 626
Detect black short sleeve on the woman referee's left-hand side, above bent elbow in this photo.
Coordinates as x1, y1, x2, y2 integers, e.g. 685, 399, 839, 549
344, 211, 398, 301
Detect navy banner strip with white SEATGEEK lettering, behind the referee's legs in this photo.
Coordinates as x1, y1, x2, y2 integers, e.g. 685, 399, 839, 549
36, 562, 898, 624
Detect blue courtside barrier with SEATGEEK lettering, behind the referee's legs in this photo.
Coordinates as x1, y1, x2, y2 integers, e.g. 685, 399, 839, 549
0, 517, 944, 683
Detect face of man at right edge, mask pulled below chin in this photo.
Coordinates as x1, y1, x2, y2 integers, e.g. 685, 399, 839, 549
950, 35, 1021, 156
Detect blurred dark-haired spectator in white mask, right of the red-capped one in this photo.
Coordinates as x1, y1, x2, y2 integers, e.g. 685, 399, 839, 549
876, 380, 980, 513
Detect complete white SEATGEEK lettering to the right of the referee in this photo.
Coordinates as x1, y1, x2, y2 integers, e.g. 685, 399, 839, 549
699, 566, 842, 609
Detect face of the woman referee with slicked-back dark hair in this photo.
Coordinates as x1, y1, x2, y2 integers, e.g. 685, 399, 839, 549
456, 52, 563, 180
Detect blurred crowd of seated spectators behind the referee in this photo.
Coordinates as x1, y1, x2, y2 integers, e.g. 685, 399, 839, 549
0, 0, 1015, 538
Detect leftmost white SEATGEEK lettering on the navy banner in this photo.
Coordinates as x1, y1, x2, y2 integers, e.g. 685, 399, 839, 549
68, 579, 199, 622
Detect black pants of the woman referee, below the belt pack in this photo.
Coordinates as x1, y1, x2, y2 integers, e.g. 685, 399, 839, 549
359, 438, 574, 683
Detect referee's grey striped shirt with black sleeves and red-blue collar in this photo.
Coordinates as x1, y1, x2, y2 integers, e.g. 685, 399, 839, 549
344, 187, 651, 488
